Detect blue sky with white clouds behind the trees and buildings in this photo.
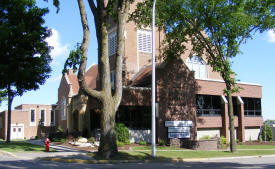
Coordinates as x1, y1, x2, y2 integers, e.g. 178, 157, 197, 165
0, 1, 275, 120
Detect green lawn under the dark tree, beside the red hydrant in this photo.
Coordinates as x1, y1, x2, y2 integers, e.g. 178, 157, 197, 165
0, 141, 54, 152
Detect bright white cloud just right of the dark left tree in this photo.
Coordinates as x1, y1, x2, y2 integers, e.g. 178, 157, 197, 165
46, 29, 69, 62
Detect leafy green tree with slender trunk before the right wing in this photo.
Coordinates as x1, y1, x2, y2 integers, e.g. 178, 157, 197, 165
130, 0, 275, 152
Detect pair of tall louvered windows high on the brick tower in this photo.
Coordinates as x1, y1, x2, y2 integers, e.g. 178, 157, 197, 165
108, 29, 152, 56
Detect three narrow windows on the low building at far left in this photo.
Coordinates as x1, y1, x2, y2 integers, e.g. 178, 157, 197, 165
30, 109, 55, 126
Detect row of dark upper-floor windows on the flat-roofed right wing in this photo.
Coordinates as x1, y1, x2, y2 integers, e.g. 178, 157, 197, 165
196, 95, 262, 116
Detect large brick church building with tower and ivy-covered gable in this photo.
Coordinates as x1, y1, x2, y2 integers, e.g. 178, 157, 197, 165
55, 1, 263, 142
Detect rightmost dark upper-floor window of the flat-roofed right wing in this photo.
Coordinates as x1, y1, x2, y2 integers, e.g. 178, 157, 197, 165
245, 97, 262, 116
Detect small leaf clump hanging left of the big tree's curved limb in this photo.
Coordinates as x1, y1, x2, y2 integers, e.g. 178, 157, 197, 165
62, 43, 84, 73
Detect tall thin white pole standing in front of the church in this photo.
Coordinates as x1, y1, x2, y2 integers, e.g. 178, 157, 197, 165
152, 0, 156, 157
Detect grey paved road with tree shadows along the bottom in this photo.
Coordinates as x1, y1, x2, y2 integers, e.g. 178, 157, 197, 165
0, 154, 275, 169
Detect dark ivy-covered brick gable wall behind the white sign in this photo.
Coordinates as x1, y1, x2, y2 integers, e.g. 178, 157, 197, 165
156, 59, 198, 140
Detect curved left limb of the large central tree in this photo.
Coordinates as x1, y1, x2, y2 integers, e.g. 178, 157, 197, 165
77, 0, 102, 100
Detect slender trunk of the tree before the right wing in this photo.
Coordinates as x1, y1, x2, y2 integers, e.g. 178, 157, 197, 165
226, 84, 237, 153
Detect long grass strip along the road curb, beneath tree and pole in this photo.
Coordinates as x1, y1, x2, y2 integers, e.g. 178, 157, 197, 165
89, 150, 275, 160
